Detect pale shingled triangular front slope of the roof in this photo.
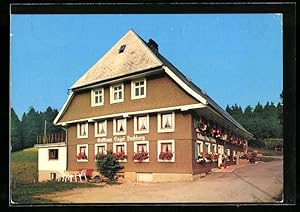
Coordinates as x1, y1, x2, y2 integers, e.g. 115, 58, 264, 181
71, 30, 162, 89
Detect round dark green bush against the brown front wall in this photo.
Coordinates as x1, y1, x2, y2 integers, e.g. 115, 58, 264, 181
96, 150, 124, 182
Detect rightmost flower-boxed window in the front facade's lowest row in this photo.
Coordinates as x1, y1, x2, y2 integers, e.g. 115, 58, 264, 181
157, 140, 175, 162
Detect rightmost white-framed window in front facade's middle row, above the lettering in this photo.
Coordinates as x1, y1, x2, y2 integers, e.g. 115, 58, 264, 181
157, 112, 175, 133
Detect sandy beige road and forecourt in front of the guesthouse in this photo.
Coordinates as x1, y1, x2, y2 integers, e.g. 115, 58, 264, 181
40, 160, 283, 203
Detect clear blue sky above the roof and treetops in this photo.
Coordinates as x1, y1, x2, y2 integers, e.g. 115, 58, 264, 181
10, 14, 283, 118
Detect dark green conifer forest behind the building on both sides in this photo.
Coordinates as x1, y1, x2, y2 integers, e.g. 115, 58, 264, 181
10, 93, 283, 151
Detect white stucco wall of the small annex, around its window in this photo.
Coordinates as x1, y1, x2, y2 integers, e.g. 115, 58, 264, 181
38, 146, 67, 171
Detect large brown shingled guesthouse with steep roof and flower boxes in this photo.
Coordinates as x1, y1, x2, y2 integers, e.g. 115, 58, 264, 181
38, 30, 252, 182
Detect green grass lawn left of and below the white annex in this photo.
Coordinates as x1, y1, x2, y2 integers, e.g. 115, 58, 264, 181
10, 148, 95, 204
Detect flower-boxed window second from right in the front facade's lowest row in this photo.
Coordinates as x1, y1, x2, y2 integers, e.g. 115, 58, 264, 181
133, 141, 149, 162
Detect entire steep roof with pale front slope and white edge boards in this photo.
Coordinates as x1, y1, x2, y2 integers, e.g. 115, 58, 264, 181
54, 30, 252, 137
